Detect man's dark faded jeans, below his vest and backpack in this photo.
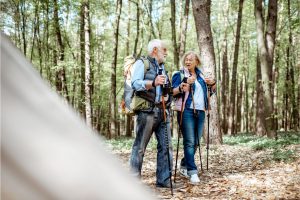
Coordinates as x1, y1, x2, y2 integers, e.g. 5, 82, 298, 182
130, 107, 173, 185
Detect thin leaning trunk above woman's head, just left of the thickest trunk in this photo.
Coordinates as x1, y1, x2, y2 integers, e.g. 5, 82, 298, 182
179, 0, 190, 58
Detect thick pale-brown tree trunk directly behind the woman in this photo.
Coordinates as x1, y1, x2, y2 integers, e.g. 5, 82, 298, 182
192, 0, 222, 144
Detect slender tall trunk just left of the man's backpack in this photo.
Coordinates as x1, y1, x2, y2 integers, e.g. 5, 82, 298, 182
109, 0, 122, 138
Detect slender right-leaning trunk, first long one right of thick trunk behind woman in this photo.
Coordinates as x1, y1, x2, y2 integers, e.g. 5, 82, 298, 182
228, 0, 244, 135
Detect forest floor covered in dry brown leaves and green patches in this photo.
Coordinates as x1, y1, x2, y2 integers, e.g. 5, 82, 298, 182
106, 134, 300, 199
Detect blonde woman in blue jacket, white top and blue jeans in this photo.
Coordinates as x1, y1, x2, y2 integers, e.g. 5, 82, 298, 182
172, 51, 215, 184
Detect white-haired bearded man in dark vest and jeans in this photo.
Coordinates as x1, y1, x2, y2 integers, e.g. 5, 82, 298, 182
130, 39, 178, 188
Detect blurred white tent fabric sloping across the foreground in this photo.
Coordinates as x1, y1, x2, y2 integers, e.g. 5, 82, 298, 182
1, 33, 154, 200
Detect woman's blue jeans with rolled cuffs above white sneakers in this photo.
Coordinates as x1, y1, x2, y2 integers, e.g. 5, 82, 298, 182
180, 108, 205, 175
